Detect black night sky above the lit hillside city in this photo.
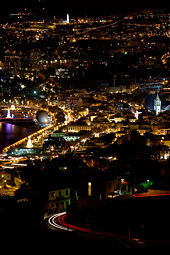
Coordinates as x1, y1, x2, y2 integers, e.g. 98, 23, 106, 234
0, 0, 168, 16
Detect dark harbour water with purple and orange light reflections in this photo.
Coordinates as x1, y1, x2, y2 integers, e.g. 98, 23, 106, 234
0, 122, 36, 151
